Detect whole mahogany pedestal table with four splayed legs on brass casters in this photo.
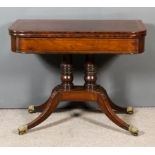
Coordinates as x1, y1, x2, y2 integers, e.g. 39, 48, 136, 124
9, 20, 146, 135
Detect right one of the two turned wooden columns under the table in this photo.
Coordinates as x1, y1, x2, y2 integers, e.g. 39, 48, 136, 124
84, 55, 97, 90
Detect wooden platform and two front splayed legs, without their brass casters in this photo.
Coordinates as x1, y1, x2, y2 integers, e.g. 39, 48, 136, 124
27, 86, 129, 130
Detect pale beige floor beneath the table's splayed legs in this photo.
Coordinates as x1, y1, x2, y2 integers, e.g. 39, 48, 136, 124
0, 107, 155, 146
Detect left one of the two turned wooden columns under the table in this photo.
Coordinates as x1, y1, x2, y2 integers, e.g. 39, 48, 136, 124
61, 55, 73, 90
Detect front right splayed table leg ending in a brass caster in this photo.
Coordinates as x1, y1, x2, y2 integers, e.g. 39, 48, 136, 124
98, 94, 138, 135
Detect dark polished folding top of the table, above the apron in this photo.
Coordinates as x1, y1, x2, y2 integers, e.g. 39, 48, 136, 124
9, 19, 146, 38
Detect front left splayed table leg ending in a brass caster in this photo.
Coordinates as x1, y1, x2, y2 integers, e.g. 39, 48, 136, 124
18, 92, 60, 135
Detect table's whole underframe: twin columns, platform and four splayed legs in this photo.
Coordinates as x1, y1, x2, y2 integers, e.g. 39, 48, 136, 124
18, 55, 138, 135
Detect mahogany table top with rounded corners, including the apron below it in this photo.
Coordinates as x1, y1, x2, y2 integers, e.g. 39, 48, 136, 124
9, 20, 146, 54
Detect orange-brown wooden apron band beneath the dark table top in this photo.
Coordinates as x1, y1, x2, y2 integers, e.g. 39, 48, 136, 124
11, 36, 144, 54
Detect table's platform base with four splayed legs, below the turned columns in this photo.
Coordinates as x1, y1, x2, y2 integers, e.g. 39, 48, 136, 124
18, 85, 138, 135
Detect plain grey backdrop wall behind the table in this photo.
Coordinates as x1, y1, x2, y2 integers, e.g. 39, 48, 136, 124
0, 8, 155, 108
